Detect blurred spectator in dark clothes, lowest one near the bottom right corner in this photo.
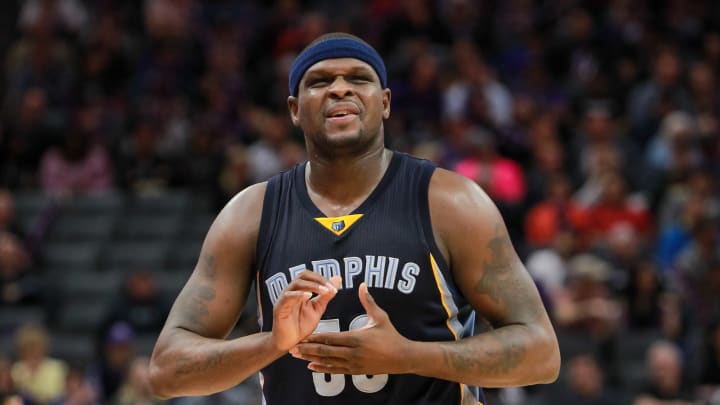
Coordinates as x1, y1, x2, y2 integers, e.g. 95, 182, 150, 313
633, 341, 697, 405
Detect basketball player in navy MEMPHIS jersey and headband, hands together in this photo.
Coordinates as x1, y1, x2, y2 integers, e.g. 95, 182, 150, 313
150, 34, 560, 405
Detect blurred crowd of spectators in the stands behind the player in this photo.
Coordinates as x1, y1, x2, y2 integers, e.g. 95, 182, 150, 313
0, 0, 720, 405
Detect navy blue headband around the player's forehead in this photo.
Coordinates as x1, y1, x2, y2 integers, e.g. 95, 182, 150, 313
288, 37, 387, 97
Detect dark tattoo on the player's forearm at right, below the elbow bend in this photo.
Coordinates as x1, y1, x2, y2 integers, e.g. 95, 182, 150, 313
444, 329, 527, 374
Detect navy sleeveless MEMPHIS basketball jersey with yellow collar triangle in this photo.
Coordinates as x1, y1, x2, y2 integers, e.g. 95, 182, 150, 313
256, 152, 483, 405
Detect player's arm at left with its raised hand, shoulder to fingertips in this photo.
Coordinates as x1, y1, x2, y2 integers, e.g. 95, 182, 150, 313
150, 184, 339, 398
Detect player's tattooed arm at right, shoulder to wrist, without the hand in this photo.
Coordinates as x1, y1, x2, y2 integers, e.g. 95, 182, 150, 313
412, 170, 560, 387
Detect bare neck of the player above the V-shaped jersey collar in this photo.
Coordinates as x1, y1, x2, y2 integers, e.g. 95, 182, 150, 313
305, 148, 393, 216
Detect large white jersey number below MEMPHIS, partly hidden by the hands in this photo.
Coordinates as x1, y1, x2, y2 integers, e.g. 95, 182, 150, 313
313, 315, 388, 397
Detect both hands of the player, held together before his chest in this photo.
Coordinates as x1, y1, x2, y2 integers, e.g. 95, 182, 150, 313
272, 271, 411, 375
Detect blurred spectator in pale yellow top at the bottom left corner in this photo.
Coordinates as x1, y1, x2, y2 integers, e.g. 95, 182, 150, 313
11, 324, 68, 404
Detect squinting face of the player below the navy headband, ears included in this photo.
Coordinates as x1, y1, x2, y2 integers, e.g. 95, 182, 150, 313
288, 58, 390, 155
